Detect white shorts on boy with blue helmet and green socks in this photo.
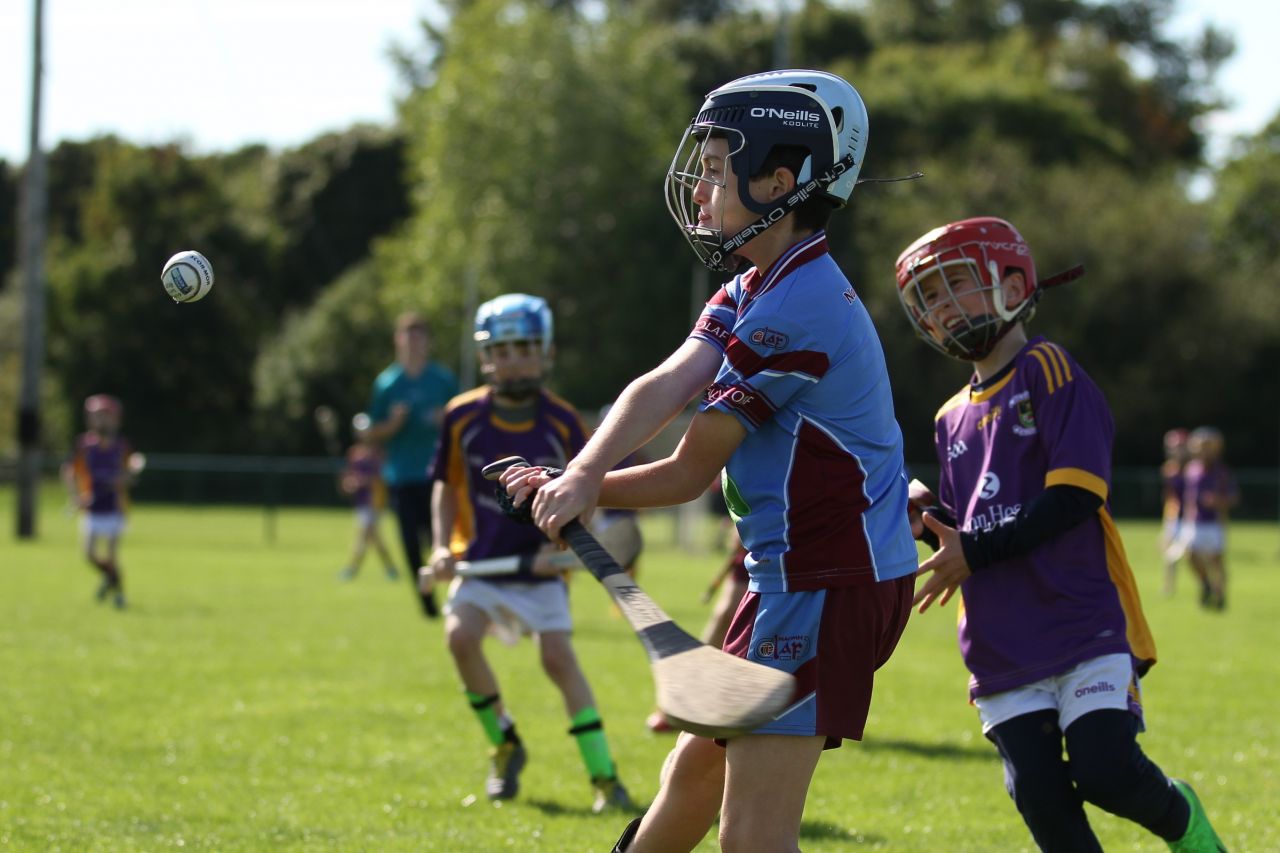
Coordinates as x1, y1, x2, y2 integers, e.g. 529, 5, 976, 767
444, 576, 573, 646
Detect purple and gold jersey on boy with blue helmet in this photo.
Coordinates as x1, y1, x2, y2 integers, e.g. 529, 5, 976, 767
431, 387, 586, 583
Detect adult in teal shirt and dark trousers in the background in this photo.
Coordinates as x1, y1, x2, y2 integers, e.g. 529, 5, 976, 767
369, 311, 458, 619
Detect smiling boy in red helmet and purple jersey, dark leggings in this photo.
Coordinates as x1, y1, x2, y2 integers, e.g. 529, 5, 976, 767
897, 216, 1221, 850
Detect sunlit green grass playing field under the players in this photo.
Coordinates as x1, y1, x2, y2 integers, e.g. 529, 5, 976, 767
0, 489, 1280, 852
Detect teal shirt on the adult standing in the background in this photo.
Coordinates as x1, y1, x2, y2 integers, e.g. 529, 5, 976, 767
369, 361, 458, 487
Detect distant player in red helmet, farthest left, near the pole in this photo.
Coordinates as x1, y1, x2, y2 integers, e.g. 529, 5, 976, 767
63, 394, 146, 608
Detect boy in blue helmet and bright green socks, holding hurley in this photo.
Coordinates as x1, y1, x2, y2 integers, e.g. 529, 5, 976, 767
431, 293, 631, 812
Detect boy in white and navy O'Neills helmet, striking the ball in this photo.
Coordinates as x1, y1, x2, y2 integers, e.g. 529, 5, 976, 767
504, 70, 916, 853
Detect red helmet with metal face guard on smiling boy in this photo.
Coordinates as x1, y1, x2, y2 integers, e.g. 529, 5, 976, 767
897, 218, 1039, 361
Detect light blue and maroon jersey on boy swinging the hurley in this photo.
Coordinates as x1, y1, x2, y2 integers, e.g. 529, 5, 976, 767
690, 232, 916, 593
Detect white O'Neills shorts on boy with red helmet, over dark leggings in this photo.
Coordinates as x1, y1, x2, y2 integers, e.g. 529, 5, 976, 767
973, 653, 1142, 734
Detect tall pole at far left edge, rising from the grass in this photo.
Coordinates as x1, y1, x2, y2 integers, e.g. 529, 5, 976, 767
18, 0, 47, 539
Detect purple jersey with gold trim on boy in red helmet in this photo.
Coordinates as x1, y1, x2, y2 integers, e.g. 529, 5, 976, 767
934, 337, 1156, 697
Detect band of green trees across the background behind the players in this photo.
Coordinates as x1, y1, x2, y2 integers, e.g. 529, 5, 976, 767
0, 0, 1280, 464
